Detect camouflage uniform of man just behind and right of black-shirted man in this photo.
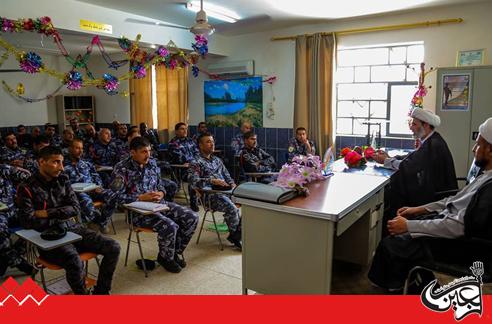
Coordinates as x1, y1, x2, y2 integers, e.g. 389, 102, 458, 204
64, 159, 116, 227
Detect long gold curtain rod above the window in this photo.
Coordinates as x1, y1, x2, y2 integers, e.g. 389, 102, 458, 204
271, 18, 464, 41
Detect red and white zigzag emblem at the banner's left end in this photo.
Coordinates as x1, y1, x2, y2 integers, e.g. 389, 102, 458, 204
0, 277, 48, 307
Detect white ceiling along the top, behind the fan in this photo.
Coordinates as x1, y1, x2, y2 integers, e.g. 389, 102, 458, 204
77, 0, 492, 35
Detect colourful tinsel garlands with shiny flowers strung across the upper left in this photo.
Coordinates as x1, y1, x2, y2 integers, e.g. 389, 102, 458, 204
0, 17, 208, 102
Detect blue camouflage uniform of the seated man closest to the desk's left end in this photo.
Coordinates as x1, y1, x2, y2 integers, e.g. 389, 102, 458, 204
188, 155, 240, 233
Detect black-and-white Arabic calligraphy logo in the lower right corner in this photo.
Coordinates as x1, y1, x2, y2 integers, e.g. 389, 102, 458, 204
421, 261, 484, 321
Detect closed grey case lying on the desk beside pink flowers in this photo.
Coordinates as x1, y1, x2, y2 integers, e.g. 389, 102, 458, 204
232, 182, 297, 204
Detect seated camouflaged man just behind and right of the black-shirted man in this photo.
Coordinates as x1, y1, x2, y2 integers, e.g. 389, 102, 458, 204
64, 138, 115, 234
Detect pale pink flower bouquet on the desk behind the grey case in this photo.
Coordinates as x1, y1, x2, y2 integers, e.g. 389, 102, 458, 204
272, 154, 325, 196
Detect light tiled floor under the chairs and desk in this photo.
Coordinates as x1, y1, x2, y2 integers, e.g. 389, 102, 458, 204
0, 199, 491, 295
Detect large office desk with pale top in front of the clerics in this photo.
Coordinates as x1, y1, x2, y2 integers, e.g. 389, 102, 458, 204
237, 173, 389, 294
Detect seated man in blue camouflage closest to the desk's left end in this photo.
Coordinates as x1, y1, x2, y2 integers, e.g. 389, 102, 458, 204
188, 133, 242, 249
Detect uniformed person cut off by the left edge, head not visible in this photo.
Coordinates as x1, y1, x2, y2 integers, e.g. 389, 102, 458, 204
0, 164, 35, 277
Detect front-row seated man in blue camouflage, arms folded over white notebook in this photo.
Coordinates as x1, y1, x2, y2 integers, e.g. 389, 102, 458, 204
111, 137, 198, 273
